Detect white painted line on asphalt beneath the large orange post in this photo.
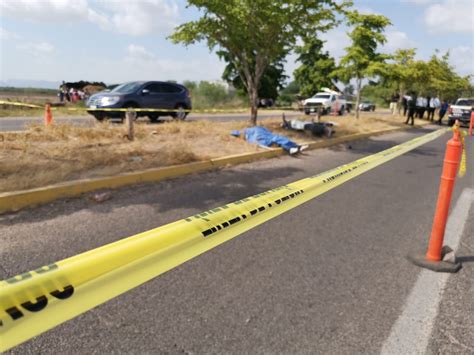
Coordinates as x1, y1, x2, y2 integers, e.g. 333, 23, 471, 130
381, 189, 474, 355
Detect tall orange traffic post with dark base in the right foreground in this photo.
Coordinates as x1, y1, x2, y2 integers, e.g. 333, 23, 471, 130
408, 121, 463, 272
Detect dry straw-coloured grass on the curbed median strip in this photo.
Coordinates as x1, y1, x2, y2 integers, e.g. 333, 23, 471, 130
0, 116, 414, 192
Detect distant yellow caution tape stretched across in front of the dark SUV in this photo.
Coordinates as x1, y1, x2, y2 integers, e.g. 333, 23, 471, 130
0, 100, 295, 113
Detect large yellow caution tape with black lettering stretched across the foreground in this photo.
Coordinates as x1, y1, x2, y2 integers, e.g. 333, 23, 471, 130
0, 129, 446, 351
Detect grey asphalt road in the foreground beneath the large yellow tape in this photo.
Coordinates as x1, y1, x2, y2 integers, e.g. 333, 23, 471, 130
0, 129, 474, 354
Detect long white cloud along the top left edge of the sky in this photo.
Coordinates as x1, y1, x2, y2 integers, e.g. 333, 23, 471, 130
0, 0, 179, 36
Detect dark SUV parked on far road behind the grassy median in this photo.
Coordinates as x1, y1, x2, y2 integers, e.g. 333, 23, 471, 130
87, 81, 192, 122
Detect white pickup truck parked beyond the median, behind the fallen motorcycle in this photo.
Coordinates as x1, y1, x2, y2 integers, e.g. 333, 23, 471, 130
303, 88, 348, 115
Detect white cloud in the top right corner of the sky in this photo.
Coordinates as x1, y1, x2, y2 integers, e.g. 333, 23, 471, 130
424, 0, 474, 33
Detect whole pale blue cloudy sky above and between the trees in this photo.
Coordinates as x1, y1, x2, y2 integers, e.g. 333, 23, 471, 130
0, 0, 474, 86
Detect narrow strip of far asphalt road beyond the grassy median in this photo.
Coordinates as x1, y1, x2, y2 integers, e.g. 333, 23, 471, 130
0, 111, 301, 132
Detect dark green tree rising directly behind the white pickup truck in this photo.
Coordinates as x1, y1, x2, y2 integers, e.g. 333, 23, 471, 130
293, 35, 336, 97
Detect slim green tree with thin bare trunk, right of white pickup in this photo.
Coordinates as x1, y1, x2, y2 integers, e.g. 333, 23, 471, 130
333, 11, 391, 118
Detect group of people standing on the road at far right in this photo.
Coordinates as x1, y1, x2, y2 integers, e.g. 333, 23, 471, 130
402, 92, 449, 126
